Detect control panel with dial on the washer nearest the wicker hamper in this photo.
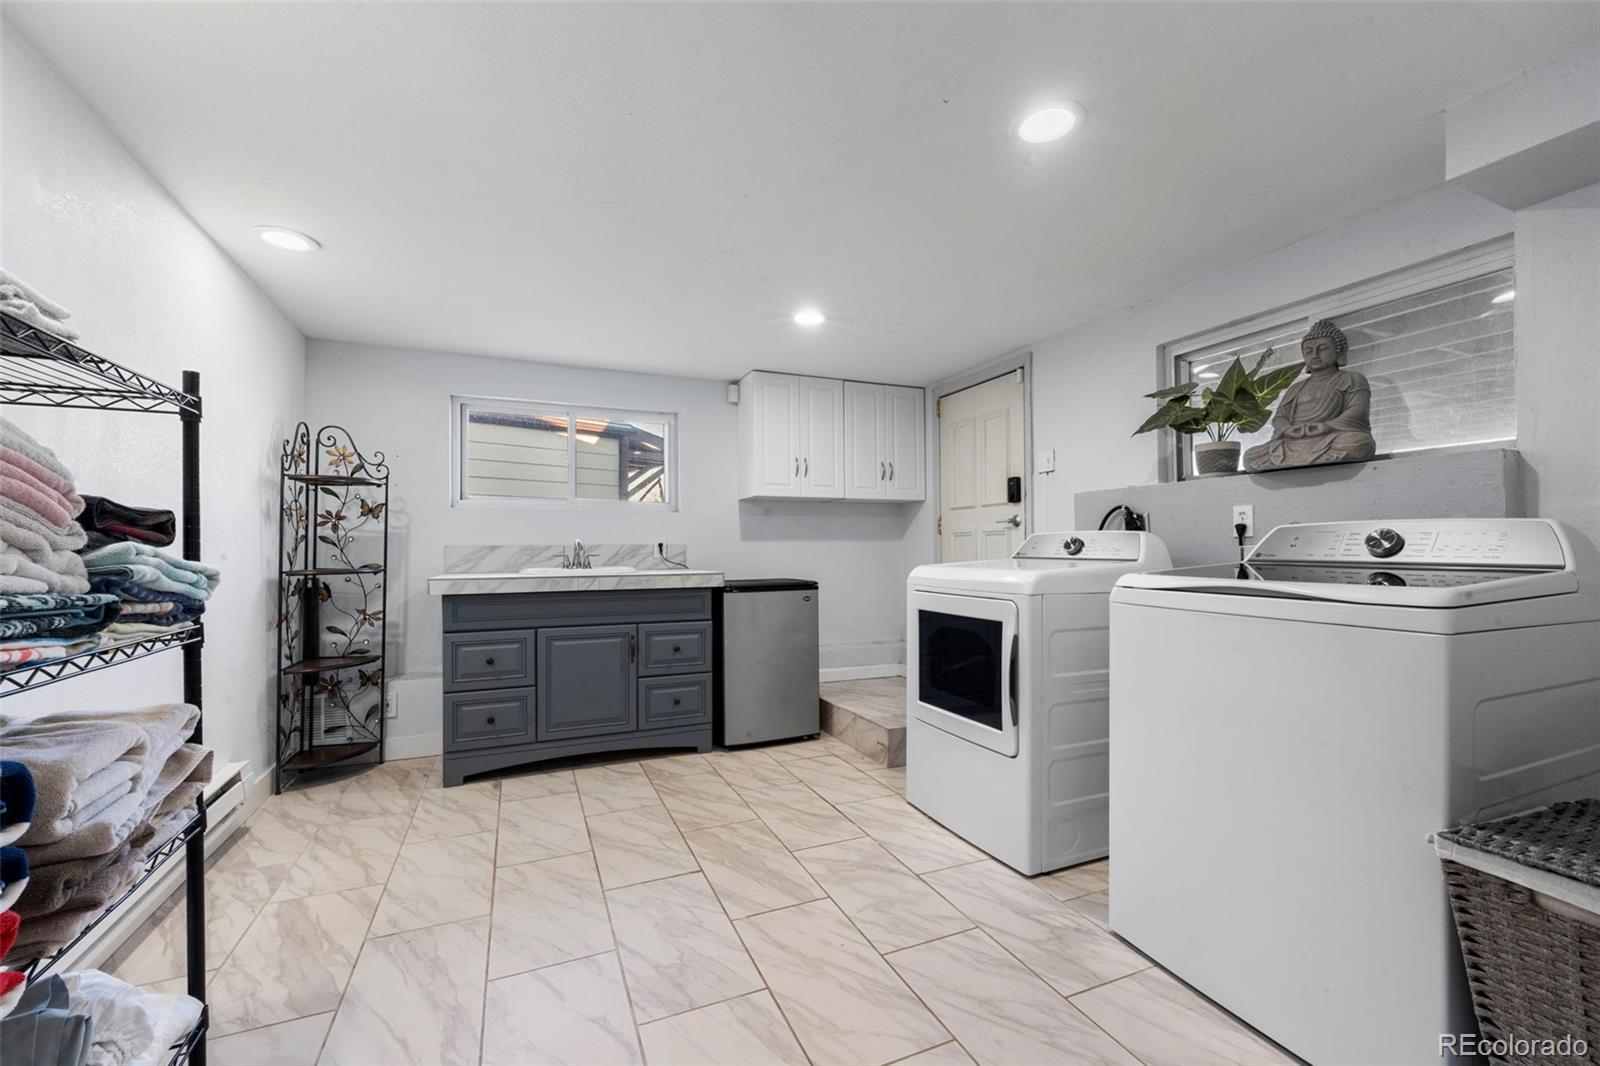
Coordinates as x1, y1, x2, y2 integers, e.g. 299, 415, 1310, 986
1250, 519, 1568, 570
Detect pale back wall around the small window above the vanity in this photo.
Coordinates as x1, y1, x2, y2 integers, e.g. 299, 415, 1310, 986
307, 341, 923, 685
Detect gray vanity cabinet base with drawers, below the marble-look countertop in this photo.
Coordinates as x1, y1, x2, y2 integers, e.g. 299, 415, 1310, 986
443, 589, 715, 784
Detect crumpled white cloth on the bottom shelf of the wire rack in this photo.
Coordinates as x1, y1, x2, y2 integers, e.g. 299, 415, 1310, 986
62, 970, 202, 1066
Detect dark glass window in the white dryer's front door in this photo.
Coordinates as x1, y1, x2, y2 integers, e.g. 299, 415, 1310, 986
917, 610, 1010, 733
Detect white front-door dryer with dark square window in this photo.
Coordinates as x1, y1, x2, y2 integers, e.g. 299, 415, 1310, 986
906, 530, 1171, 874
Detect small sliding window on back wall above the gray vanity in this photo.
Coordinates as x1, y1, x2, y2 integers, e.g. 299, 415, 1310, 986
453, 397, 677, 507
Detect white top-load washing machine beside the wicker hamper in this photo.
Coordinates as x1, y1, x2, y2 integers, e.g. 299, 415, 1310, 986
1110, 519, 1600, 1064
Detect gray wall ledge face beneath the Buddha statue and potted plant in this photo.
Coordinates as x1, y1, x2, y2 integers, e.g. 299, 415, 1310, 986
1074, 448, 1525, 567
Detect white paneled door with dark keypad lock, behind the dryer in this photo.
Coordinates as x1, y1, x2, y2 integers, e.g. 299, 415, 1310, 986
939, 368, 1027, 562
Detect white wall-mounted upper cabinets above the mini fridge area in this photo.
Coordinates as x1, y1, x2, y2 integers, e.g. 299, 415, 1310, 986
739, 371, 925, 501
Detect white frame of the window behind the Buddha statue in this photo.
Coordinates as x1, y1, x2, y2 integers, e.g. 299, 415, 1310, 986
1155, 234, 1517, 482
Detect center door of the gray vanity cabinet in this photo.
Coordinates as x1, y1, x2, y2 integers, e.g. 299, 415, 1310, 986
536, 626, 638, 739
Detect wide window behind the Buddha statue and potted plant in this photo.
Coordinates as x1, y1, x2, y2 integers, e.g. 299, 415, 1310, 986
1162, 237, 1517, 480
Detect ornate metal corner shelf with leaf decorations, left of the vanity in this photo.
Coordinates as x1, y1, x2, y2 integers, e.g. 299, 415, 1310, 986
274, 423, 389, 792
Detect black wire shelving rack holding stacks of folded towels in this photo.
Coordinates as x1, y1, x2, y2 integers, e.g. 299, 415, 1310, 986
0, 312, 210, 1066
